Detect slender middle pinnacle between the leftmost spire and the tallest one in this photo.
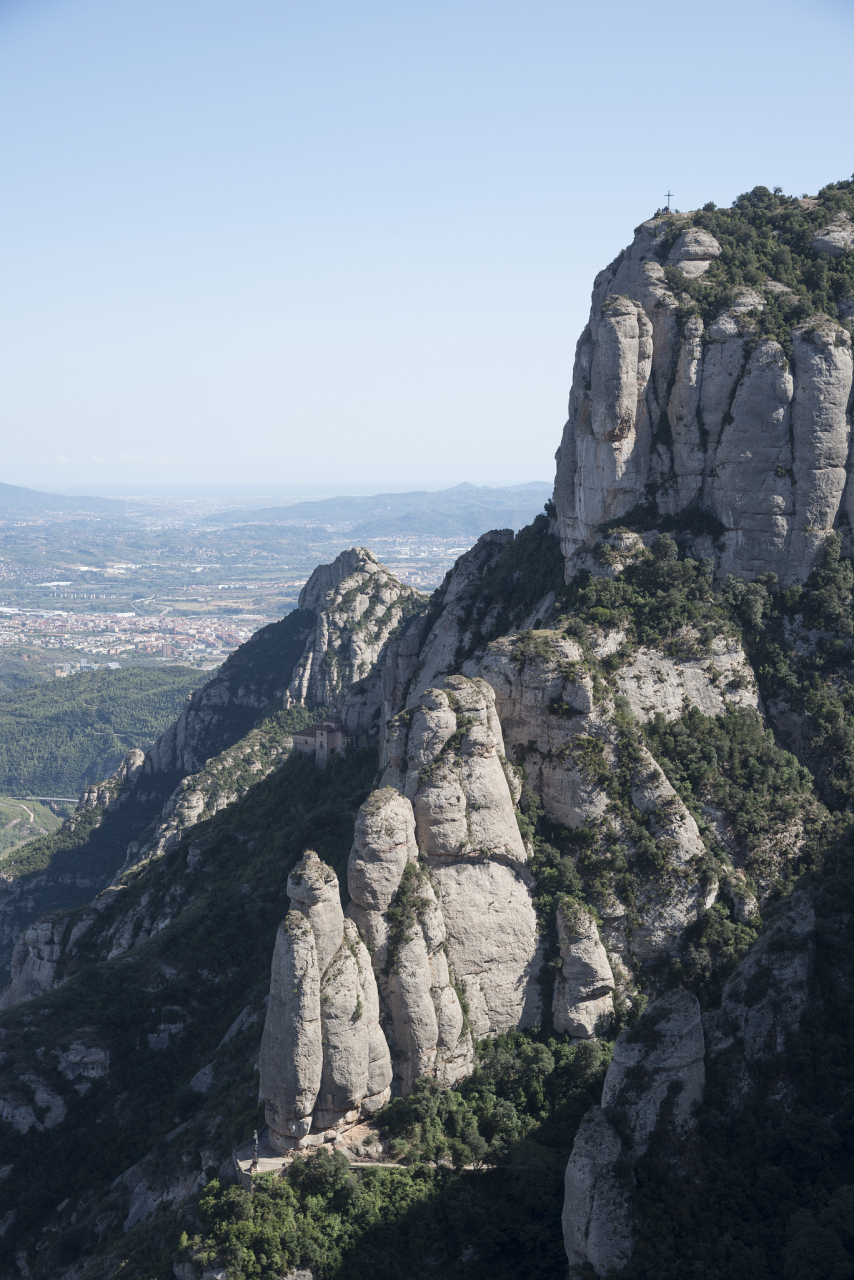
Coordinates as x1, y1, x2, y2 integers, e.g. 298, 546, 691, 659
347, 787, 474, 1096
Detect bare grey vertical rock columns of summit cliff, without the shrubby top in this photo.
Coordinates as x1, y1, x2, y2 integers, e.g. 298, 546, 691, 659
554, 219, 854, 582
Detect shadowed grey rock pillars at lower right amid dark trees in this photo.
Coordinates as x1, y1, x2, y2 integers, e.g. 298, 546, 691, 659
562, 991, 705, 1276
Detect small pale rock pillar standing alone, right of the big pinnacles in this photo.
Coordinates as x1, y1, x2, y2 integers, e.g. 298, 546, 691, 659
552, 900, 615, 1039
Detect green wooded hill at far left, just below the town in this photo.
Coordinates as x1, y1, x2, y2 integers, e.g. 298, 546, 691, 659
0, 667, 200, 796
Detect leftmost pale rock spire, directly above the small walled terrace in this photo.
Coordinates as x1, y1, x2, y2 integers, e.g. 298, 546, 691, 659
259, 851, 392, 1149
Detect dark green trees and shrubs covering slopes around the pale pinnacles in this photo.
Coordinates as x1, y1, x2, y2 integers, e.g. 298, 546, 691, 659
8, 520, 854, 1280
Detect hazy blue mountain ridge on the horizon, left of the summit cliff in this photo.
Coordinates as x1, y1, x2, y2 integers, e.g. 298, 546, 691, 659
209, 480, 552, 543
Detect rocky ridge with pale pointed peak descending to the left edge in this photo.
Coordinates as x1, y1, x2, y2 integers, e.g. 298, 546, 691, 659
0, 548, 426, 1007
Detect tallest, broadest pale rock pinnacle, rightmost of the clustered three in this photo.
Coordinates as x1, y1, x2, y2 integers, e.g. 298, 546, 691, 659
383, 676, 542, 1037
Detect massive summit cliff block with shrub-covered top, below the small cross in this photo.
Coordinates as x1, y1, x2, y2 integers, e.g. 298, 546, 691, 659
554, 180, 854, 582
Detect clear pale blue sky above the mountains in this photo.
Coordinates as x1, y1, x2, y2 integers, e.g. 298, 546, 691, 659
0, 0, 854, 492
